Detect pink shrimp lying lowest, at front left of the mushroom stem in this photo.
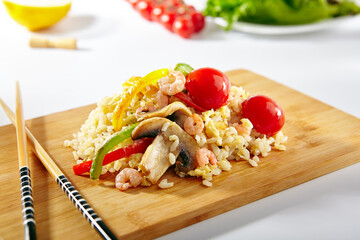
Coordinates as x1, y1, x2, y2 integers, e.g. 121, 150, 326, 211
115, 168, 143, 191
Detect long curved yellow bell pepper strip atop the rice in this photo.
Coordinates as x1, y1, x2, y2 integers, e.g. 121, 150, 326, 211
112, 68, 169, 131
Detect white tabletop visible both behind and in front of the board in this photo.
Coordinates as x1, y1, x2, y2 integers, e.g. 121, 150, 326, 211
0, 0, 360, 239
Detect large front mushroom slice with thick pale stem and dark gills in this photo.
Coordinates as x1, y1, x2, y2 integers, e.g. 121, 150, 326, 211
132, 117, 199, 183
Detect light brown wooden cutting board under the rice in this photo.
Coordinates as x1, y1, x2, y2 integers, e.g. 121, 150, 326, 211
0, 70, 360, 239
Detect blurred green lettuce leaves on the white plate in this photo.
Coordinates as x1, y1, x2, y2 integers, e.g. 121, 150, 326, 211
204, 0, 360, 29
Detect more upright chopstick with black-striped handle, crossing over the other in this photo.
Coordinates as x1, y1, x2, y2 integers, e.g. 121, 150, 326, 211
15, 82, 36, 240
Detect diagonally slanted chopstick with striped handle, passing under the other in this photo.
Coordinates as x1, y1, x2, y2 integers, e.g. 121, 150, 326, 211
0, 96, 117, 239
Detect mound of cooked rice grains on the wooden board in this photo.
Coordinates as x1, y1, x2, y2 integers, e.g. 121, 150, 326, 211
64, 68, 287, 188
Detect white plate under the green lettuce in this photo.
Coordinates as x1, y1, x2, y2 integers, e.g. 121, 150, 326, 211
214, 17, 351, 35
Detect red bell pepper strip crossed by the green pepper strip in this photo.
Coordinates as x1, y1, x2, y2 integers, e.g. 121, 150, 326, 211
73, 138, 154, 175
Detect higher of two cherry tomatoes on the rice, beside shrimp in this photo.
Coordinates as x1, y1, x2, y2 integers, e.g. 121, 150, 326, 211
185, 68, 231, 110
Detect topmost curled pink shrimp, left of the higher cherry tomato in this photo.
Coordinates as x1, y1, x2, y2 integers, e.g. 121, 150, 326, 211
158, 71, 186, 96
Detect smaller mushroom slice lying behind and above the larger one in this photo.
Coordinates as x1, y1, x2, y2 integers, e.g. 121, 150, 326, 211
139, 102, 192, 127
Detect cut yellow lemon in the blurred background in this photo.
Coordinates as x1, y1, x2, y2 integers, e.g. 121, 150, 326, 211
3, 0, 71, 31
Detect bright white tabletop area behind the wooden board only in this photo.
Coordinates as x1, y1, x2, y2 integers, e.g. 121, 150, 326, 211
0, 0, 360, 124
